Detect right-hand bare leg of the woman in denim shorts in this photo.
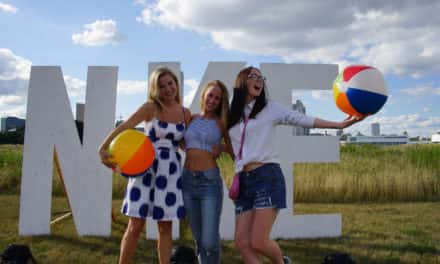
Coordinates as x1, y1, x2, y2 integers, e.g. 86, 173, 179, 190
250, 208, 283, 264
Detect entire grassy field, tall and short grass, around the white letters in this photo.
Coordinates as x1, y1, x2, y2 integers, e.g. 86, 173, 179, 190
0, 144, 440, 264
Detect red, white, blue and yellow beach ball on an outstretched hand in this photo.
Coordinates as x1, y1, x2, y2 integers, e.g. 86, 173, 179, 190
333, 65, 388, 117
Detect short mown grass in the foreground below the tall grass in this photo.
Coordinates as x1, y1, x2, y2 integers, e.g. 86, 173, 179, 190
0, 195, 440, 264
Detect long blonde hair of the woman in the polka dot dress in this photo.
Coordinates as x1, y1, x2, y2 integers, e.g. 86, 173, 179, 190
148, 67, 181, 110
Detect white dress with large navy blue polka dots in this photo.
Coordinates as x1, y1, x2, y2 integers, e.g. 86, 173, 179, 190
122, 119, 185, 221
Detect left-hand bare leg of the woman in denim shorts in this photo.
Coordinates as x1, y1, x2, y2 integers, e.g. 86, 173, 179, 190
234, 210, 262, 264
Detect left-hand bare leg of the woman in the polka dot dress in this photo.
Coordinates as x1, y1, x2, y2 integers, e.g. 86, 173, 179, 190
119, 217, 145, 264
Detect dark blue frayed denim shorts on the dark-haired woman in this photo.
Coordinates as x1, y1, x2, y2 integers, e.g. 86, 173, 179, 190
234, 163, 286, 215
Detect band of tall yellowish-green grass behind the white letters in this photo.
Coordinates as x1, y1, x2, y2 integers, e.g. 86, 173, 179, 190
0, 144, 440, 203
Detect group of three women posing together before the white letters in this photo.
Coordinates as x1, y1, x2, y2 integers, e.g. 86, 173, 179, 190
100, 67, 361, 263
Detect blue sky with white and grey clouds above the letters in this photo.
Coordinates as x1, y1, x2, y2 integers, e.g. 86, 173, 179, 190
0, 0, 440, 136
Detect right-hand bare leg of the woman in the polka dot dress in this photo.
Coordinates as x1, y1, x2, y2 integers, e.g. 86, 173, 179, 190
157, 221, 173, 264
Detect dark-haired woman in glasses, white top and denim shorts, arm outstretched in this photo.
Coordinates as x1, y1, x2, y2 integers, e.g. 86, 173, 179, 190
228, 67, 362, 264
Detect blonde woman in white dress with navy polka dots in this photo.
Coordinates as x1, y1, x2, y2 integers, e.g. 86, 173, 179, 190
99, 68, 191, 264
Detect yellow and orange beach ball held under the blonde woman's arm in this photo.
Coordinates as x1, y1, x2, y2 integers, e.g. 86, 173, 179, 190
109, 129, 154, 177
